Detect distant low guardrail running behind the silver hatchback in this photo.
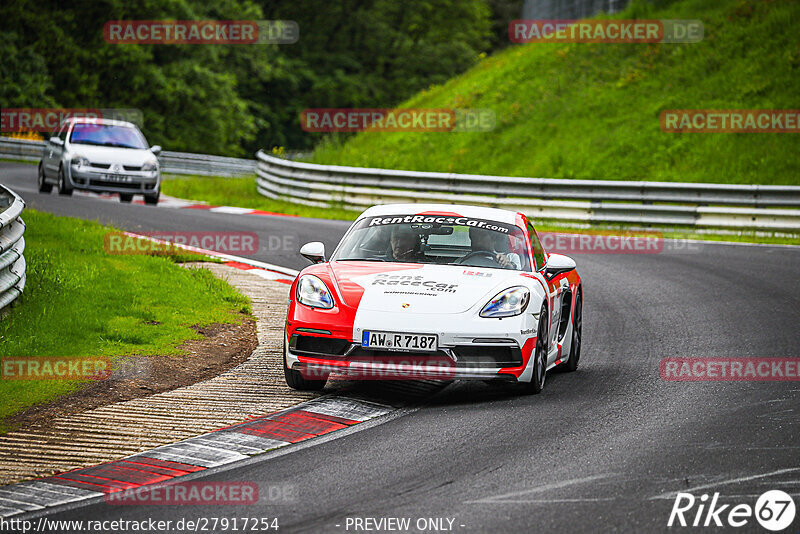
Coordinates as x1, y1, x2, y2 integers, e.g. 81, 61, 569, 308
0, 137, 256, 176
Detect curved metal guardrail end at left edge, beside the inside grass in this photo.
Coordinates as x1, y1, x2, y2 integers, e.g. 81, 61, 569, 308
0, 185, 25, 310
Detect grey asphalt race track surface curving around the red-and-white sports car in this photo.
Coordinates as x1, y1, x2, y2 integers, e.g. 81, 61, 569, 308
0, 163, 800, 533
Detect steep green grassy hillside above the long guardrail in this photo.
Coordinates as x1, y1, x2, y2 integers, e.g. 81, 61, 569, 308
313, 0, 800, 184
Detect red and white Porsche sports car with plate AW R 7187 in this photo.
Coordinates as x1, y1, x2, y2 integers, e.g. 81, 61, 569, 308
284, 204, 583, 393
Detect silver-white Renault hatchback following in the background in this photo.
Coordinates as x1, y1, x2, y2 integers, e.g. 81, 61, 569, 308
39, 117, 161, 204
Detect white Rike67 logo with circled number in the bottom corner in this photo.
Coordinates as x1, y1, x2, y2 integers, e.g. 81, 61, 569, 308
667, 490, 796, 532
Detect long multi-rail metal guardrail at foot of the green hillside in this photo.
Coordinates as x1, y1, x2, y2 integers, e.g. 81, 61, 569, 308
256, 151, 800, 231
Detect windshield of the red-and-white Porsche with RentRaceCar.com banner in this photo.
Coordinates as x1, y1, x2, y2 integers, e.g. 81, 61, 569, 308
331, 215, 531, 271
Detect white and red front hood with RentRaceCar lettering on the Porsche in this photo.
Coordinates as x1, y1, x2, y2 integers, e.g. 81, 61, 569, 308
329, 262, 523, 313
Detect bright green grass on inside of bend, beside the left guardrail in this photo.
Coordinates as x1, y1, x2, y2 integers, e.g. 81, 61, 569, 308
0, 210, 251, 432
